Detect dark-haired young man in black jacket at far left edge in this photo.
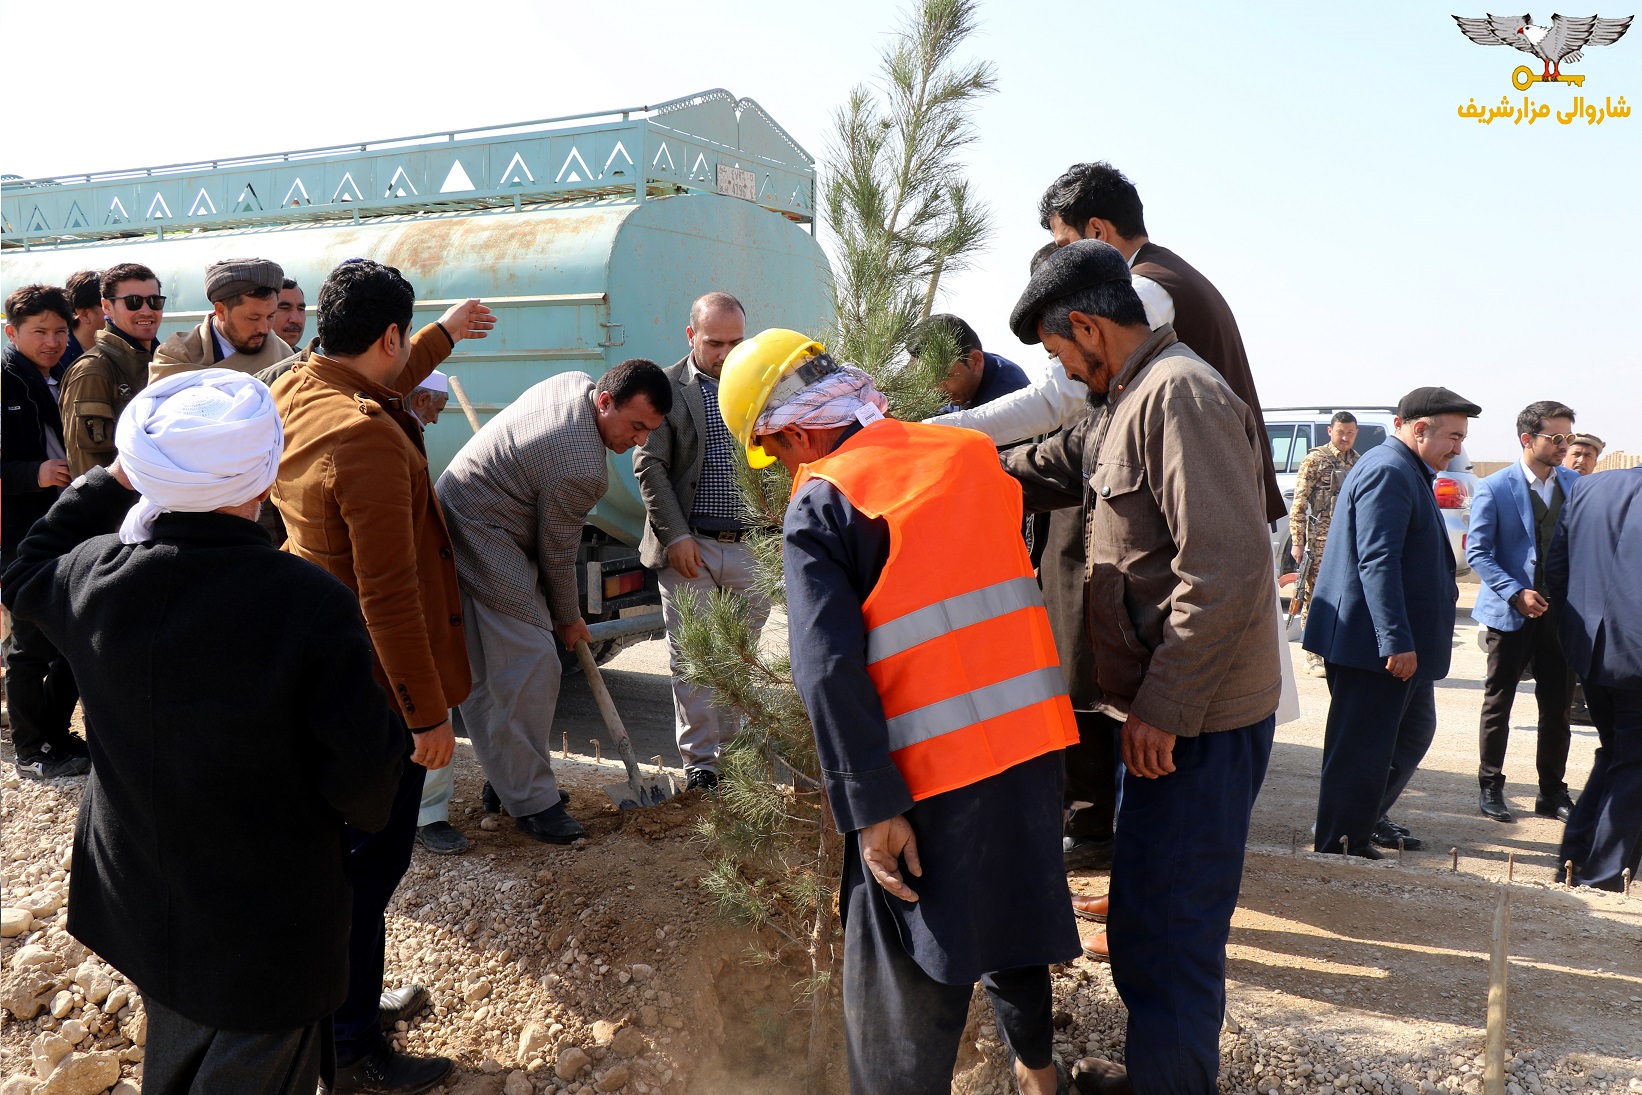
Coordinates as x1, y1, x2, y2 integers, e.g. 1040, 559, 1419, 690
0, 286, 90, 780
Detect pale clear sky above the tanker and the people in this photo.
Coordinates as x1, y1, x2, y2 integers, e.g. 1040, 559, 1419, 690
0, 0, 1642, 460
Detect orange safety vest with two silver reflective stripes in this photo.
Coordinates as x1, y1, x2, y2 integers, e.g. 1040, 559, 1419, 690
793, 419, 1077, 801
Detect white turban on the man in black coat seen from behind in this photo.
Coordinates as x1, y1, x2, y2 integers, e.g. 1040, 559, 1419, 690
113, 369, 286, 543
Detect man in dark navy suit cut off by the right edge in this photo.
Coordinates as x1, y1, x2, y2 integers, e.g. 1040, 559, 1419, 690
1545, 468, 1642, 890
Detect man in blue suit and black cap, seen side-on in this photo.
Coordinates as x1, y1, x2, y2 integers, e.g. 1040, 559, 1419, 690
1304, 387, 1483, 859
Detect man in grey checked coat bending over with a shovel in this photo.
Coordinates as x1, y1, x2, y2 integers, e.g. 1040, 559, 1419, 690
435, 358, 673, 844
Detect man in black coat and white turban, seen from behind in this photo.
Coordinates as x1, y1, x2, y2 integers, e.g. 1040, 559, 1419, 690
5, 369, 411, 1095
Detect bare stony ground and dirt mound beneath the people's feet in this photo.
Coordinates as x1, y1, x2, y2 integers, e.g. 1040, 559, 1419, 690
0, 604, 1642, 1095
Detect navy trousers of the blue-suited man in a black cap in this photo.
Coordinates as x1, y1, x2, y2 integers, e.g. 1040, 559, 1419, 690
1315, 662, 1437, 852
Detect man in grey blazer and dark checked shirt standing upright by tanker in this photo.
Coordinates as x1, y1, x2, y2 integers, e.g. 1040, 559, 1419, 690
632, 292, 770, 790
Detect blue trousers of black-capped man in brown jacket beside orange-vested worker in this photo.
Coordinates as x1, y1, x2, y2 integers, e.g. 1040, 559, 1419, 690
1107, 716, 1276, 1095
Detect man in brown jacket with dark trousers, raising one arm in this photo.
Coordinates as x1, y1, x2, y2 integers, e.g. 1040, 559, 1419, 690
273, 259, 496, 1095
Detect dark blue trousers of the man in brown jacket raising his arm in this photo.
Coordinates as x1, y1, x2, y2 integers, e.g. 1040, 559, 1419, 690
332, 760, 427, 1067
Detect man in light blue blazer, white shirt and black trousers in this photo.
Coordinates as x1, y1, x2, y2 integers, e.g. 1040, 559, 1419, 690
1465, 399, 1580, 821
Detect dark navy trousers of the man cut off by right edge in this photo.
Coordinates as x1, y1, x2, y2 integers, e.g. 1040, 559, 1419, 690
1558, 681, 1642, 890
